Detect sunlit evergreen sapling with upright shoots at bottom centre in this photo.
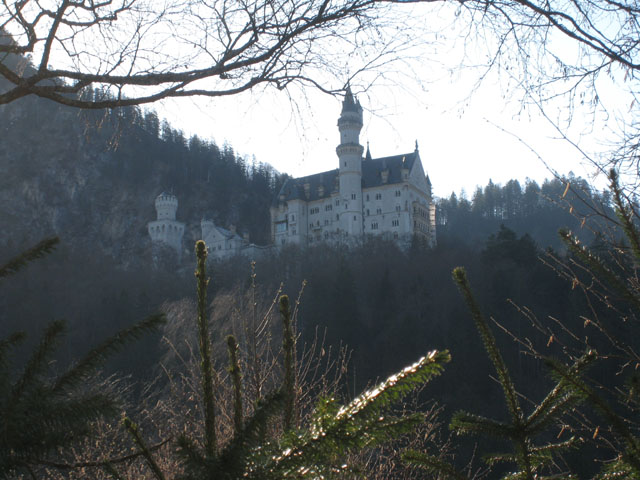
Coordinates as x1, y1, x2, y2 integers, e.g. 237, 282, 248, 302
117, 241, 450, 480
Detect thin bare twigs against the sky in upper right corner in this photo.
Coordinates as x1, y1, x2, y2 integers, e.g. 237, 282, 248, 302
450, 0, 640, 188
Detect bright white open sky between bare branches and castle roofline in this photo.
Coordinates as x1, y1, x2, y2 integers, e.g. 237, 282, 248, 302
156, 3, 607, 196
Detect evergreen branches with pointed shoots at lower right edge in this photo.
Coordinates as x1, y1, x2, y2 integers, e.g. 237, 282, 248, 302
404, 170, 640, 480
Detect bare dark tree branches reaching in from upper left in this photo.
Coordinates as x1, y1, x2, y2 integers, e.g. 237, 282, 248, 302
0, 0, 422, 108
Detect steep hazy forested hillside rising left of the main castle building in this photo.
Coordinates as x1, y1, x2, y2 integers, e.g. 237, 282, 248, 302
0, 88, 282, 266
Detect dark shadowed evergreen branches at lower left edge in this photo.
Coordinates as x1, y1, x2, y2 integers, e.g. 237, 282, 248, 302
0, 238, 163, 477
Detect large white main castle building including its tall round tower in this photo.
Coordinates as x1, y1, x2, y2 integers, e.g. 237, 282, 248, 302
271, 88, 436, 247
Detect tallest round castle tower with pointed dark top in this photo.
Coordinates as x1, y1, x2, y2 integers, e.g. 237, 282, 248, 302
336, 86, 364, 238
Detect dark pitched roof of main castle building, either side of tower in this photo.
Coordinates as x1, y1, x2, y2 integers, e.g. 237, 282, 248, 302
275, 151, 418, 204
